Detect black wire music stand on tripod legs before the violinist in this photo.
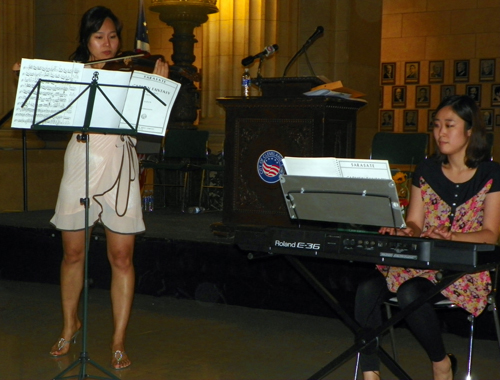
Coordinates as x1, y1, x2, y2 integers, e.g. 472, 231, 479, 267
22, 71, 166, 380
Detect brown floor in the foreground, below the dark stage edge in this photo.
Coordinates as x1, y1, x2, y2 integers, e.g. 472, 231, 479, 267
0, 281, 500, 380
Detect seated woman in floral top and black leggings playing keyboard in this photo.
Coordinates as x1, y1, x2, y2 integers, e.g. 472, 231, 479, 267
355, 95, 500, 380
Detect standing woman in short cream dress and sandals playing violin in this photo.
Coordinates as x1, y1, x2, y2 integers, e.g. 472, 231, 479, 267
50, 6, 168, 369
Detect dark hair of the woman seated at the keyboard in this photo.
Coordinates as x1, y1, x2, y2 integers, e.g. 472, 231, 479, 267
435, 95, 491, 168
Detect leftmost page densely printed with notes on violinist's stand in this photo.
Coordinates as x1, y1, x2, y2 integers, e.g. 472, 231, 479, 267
12, 58, 83, 129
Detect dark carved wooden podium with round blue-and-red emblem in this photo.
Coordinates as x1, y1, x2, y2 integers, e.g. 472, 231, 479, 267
217, 87, 366, 227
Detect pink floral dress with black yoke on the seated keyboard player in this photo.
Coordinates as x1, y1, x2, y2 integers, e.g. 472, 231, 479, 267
377, 159, 500, 316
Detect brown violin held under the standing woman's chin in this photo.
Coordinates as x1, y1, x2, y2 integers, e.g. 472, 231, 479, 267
92, 52, 201, 82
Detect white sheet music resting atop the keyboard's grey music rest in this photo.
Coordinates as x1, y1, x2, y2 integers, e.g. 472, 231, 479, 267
282, 157, 392, 179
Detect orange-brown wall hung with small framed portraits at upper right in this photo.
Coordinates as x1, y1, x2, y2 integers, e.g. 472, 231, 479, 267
381, 0, 500, 158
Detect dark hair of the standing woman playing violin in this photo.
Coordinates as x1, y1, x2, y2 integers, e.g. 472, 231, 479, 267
69, 6, 122, 62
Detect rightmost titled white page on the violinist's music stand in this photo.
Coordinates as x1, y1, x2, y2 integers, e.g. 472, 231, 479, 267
120, 71, 181, 136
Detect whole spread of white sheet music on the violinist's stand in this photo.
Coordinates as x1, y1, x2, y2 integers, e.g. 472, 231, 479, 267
12, 59, 181, 136
